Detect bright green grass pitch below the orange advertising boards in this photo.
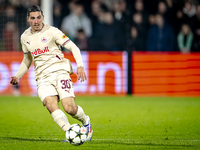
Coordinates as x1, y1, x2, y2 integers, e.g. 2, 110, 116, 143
0, 96, 200, 150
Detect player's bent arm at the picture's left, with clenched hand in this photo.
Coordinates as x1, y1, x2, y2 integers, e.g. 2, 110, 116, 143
10, 39, 33, 85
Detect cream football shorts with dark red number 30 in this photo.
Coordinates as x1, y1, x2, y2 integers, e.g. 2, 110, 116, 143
37, 71, 75, 102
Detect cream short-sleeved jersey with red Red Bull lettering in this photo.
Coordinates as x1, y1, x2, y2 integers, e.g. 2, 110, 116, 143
21, 24, 76, 80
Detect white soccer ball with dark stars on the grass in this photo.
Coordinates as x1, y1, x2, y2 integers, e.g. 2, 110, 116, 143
66, 124, 87, 145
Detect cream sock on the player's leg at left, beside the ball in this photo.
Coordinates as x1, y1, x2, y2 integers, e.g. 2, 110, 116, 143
51, 109, 70, 131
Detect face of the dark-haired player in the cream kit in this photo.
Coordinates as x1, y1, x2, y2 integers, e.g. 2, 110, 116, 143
27, 11, 44, 32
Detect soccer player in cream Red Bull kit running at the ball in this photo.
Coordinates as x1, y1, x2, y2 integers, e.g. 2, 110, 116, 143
10, 5, 93, 141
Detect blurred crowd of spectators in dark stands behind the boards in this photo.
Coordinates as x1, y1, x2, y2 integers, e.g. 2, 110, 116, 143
0, 0, 200, 53
